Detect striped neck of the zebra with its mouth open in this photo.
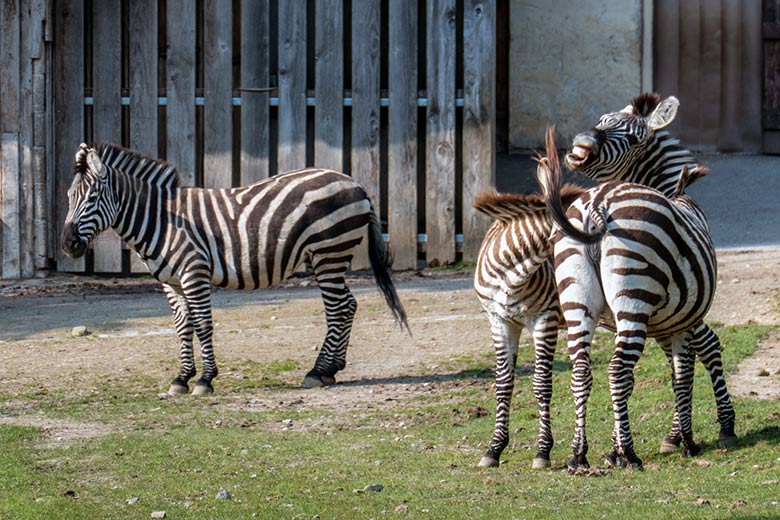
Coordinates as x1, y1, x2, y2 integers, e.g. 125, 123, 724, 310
626, 131, 695, 198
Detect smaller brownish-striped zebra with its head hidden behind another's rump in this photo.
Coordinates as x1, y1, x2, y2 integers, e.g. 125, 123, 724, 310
474, 184, 584, 468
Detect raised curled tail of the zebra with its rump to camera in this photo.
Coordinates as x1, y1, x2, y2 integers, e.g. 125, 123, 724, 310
536, 126, 605, 244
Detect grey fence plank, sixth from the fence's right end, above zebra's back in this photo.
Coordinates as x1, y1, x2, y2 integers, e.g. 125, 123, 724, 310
278, 0, 306, 173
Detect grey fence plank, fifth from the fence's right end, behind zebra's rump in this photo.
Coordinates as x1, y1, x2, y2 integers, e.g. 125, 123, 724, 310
314, 0, 344, 171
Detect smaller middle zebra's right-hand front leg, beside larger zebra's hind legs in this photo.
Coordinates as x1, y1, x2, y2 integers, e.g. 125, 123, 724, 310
532, 316, 560, 469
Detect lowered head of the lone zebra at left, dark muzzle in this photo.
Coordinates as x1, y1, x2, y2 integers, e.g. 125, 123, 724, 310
60, 143, 117, 258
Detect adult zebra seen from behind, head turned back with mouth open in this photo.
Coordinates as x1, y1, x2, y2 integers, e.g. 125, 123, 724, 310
539, 94, 734, 470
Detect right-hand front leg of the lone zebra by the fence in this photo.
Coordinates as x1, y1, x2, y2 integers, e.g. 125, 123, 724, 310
182, 275, 218, 395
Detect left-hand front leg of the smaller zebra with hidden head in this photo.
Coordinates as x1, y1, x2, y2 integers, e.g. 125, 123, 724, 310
479, 314, 522, 468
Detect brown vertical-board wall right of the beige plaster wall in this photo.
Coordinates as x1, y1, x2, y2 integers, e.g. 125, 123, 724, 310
653, 0, 762, 152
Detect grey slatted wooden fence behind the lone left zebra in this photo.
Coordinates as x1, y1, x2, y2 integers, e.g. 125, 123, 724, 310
35, 0, 496, 277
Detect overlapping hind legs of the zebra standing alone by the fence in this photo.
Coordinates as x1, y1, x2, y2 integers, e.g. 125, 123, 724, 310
301, 266, 357, 388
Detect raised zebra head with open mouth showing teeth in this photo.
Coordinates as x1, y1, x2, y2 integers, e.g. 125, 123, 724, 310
566, 94, 680, 182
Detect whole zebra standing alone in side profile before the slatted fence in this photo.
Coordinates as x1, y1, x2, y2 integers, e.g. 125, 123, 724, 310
61, 144, 408, 394
